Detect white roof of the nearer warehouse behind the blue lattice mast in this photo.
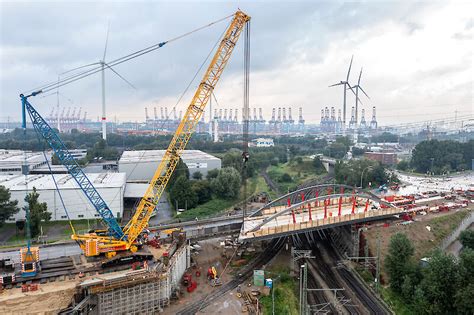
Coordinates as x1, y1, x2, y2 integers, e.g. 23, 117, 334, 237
0, 173, 126, 191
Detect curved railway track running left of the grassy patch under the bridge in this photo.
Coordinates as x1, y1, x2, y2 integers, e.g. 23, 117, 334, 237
176, 238, 284, 315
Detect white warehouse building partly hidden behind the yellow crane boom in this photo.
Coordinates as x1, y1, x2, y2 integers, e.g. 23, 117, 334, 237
118, 150, 221, 182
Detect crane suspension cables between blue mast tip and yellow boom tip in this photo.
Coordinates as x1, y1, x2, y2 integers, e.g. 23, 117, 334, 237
24, 14, 233, 95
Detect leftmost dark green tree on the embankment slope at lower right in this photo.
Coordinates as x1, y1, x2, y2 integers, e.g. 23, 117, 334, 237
385, 233, 415, 293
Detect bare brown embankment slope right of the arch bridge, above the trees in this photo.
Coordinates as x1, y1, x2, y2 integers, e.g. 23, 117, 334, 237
362, 204, 474, 282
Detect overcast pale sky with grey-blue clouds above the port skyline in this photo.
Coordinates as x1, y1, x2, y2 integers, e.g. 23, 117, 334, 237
0, 0, 474, 124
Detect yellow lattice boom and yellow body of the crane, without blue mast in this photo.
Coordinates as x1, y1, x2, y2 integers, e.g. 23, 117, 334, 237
71, 10, 250, 258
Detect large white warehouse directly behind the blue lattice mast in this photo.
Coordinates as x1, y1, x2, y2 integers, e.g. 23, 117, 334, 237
0, 173, 125, 221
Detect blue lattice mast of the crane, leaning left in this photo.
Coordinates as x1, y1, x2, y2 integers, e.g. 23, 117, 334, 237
20, 95, 126, 239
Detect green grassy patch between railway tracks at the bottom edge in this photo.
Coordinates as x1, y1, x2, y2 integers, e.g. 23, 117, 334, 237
260, 267, 298, 315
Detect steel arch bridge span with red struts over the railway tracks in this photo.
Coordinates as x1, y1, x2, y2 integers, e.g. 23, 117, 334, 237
239, 184, 405, 241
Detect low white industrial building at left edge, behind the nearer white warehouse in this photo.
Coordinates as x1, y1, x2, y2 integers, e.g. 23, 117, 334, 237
0, 149, 51, 175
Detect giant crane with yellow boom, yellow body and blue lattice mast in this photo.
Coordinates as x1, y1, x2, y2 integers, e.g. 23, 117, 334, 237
20, 10, 250, 259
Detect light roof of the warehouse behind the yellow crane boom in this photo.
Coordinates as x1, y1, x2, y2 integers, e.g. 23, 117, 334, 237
119, 150, 220, 163
